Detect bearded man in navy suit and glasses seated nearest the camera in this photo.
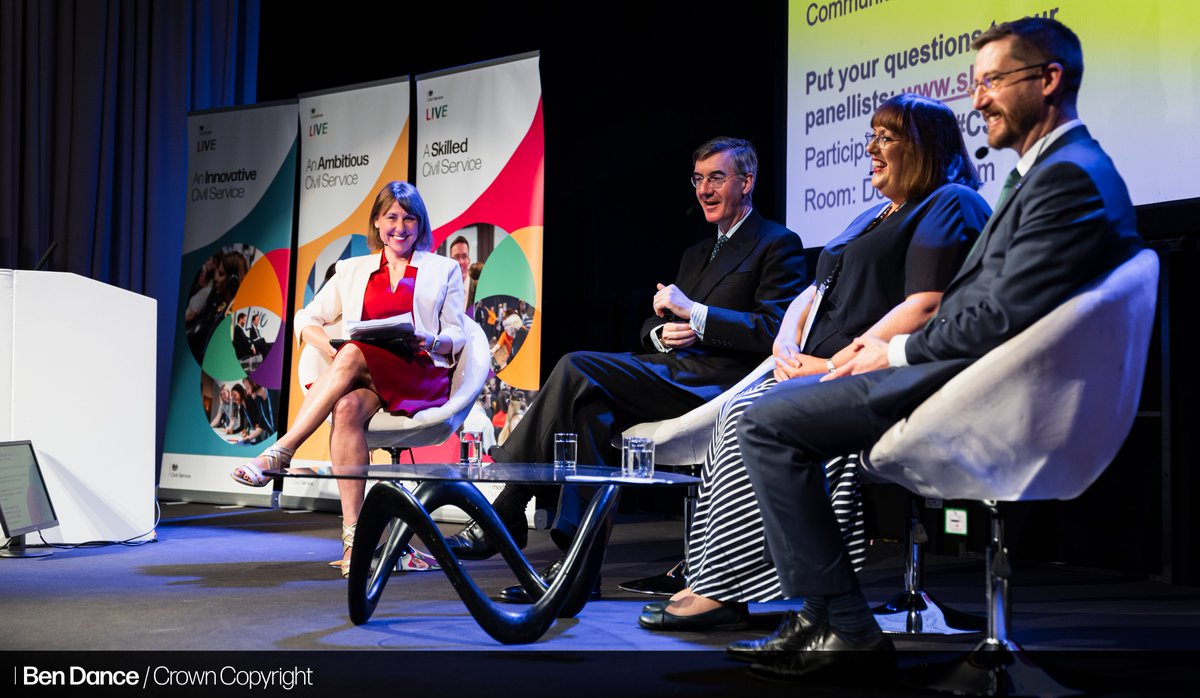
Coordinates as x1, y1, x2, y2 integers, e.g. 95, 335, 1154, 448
730, 18, 1141, 678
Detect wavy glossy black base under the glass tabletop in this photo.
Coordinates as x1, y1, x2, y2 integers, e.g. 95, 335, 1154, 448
347, 480, 620, 644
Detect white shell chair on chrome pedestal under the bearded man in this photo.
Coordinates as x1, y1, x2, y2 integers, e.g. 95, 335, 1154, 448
862, 249, 1158, 691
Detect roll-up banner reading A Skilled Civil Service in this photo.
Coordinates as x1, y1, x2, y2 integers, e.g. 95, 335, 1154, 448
415, 53, 545, 503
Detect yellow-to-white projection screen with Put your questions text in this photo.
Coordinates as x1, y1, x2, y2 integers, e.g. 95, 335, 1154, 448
787, 0, 1200, 246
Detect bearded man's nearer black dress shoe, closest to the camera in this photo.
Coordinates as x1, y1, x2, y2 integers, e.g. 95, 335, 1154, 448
750, 625, 896, 682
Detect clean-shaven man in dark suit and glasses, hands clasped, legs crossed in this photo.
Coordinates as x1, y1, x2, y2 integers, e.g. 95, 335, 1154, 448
450, 138, 808, 568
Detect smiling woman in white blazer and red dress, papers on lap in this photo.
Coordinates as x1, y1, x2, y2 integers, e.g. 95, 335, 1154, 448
230, 182, 466, 573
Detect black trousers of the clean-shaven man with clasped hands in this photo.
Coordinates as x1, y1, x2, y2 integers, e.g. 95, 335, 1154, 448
492, 351, 729, 547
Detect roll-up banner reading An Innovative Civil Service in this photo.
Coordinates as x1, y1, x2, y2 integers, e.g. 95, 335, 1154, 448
160, 102, 296, 503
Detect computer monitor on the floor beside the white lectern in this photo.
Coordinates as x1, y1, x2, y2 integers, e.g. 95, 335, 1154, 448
0, 441, 59, 558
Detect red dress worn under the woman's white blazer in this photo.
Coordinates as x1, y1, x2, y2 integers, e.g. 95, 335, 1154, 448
353, 260, 450, 416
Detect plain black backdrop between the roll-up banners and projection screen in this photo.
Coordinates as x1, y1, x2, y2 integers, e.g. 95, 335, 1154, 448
258, 0, 805, 378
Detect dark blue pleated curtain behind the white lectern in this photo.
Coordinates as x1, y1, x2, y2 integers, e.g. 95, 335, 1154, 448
0, 0, 259, 465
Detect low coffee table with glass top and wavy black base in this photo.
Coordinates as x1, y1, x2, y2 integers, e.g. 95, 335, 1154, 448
264, 463, 700, 644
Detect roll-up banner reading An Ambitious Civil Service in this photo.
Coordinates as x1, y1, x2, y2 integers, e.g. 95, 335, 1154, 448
283, 77, 410, 508
